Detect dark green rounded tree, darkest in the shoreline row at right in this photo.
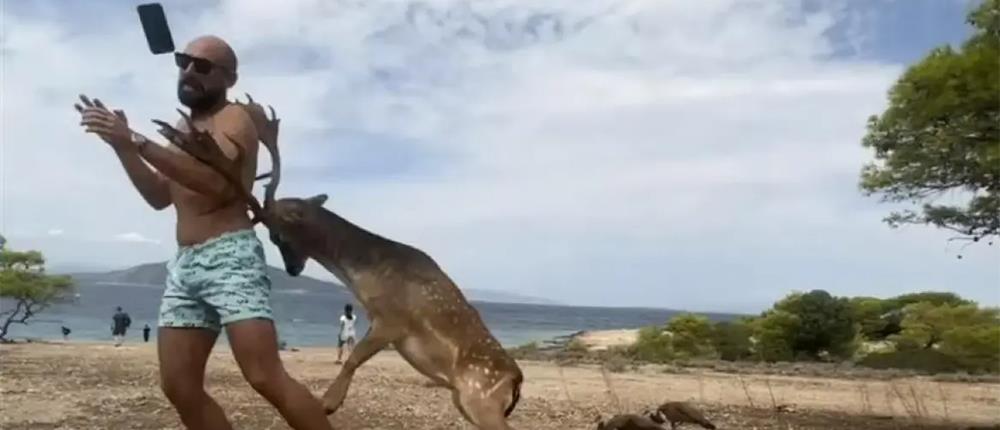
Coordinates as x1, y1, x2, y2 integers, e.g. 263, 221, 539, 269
774, 290, 857, 358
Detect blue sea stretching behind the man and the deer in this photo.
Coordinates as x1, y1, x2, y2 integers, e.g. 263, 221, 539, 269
0, 283, 733, 347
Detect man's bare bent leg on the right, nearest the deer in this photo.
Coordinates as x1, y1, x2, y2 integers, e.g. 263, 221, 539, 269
226, 319, 333, 430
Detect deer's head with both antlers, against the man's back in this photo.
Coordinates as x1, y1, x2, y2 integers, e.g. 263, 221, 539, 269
153, 94, 327, 276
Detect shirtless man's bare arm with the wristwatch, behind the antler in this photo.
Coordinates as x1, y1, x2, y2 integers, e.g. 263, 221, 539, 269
139, 108, 258, 199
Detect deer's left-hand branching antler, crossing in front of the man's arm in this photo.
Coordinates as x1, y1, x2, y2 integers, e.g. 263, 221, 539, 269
153, 106, 266, 221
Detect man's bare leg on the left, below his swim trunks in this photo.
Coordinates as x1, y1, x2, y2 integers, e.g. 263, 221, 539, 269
156, 327, 233, 430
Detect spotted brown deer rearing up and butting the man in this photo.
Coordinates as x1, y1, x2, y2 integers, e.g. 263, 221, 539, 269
156, 95, 524, 430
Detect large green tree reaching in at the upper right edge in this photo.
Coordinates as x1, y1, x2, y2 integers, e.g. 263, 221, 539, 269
860, 0, 1000, 243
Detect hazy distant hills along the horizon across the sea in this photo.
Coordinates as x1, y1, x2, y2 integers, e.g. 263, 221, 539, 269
70, 262, 558, 305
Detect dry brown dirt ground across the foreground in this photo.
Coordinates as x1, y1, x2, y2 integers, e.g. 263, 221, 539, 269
0, 343, 1000, 430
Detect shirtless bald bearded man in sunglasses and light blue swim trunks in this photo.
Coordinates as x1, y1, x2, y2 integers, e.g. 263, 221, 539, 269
75, 36, 332, 430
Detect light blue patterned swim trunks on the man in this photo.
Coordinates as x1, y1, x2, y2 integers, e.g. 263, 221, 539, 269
159, 229, 273, 331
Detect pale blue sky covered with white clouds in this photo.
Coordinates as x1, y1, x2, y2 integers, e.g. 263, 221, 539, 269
0, 0, 1000, 312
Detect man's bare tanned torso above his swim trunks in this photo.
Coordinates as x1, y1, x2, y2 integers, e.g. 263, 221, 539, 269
170, 104, 257, 246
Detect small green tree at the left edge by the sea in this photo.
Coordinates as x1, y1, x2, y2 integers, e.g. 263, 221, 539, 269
0, 249, 73, 342
